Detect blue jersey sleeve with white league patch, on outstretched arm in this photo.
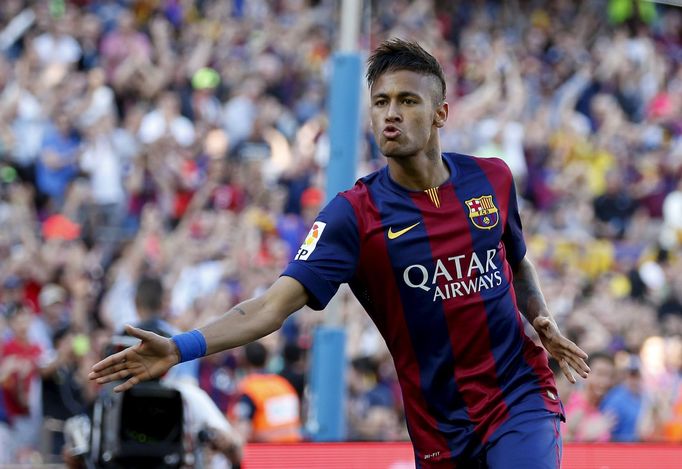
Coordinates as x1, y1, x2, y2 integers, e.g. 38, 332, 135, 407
282, 195, 360, 310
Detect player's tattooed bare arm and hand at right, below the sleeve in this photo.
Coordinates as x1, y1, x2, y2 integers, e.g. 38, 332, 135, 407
514, 257, 590, 383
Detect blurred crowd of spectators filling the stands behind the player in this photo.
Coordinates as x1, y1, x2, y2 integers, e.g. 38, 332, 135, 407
0, 0, 682, 464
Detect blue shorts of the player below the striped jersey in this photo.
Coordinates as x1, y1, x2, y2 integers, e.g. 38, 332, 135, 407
417, 410, 562, 469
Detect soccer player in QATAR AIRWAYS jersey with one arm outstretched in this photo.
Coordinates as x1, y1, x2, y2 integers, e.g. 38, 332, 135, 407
90, 39, 589, 469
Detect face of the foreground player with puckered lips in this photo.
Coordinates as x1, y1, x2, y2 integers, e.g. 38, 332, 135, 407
370, 70, 447, 158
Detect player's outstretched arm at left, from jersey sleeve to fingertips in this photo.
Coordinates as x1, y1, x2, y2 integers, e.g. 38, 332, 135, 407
89, 192, 359, 392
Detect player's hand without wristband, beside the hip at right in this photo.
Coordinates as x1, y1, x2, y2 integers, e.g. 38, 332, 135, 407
533, 316, 590, 383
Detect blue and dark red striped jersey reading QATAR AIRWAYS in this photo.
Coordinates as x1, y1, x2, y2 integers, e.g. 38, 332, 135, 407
283, 153, 562, 467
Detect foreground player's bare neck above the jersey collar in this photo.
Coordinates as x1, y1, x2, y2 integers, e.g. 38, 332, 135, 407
388, 147, 450, 190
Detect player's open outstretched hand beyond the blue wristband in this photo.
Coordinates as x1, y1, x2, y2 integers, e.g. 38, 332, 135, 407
88, 326, 180, 392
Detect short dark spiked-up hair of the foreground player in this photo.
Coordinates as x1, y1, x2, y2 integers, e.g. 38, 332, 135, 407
367, 38, 446, 99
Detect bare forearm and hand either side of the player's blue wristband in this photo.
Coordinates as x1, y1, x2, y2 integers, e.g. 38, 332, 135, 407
89, 276, 308, 392
